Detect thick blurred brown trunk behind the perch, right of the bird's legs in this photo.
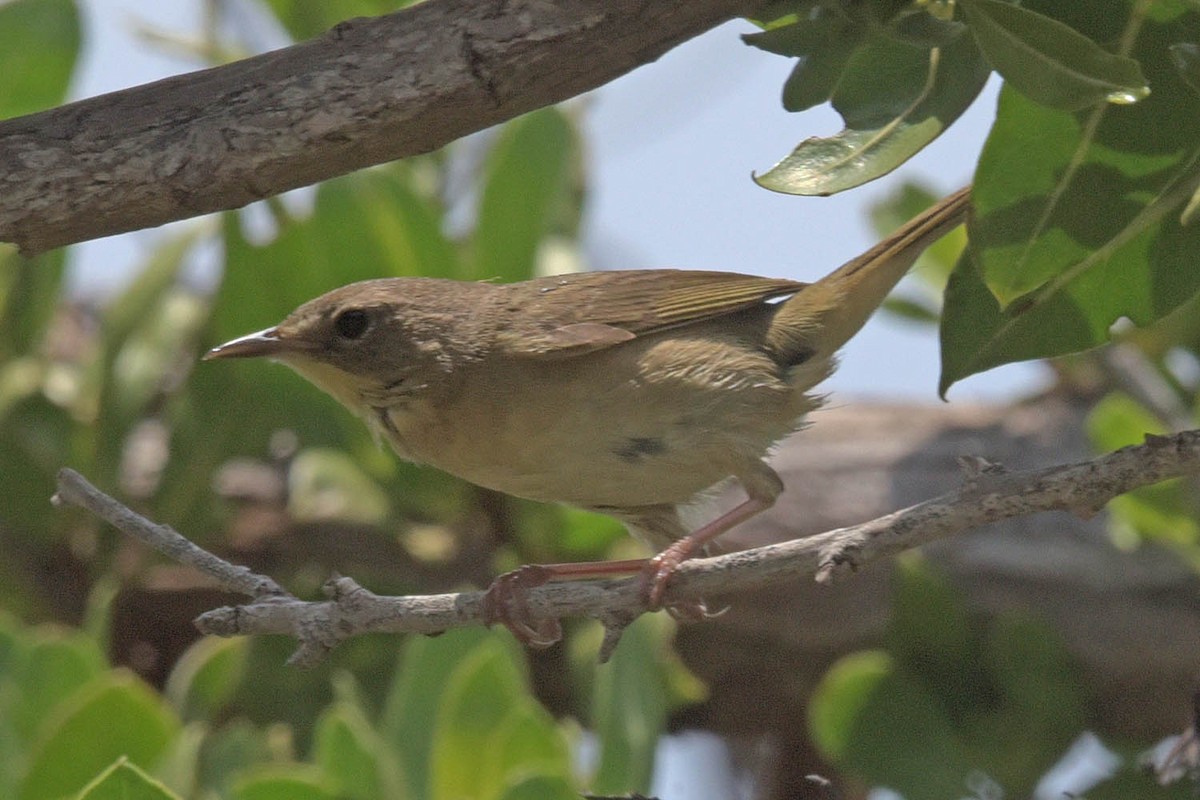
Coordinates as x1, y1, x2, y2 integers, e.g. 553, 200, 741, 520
677, 399, 1200, 798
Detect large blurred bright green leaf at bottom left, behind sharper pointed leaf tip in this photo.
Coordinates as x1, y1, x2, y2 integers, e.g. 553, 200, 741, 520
20, 669, 180, 800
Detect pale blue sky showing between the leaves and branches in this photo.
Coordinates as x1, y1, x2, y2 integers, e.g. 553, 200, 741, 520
73, 0, 1042, 402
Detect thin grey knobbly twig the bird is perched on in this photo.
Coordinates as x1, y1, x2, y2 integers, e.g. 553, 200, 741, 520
55, 431, 1200, 666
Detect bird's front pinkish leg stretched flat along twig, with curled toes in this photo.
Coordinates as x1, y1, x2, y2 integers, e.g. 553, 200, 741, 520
484, 559, 647, 648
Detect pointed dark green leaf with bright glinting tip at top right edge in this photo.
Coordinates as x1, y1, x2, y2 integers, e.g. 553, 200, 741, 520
961, 0, 1150, 112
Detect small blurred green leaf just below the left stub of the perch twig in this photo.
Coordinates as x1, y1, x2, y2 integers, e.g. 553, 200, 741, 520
163, 636, 250, 720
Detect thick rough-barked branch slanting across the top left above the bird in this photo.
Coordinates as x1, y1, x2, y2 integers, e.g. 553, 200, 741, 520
0, 0, 756, 254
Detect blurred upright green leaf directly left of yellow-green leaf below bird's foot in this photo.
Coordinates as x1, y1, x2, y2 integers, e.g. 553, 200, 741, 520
380, 627, 496, 798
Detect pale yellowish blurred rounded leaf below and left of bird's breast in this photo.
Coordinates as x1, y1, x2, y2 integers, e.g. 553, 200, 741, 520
288, 447, 390, 525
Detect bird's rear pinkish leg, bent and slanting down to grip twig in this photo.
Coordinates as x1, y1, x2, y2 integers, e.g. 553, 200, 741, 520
642, 462, 784, 606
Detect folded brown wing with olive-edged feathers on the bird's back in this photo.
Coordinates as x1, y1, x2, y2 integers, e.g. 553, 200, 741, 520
498, 270, 808, 359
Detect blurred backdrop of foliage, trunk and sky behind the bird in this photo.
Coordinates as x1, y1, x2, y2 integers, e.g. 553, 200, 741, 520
7, 0, 1200, 800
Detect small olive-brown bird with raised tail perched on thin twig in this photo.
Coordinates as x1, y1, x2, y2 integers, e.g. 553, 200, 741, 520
205, 188, 970, 645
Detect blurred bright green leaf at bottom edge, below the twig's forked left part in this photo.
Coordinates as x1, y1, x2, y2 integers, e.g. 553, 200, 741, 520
313, 700, 407, 800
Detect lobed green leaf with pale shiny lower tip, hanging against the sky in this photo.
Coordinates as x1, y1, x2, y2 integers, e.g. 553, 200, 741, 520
755, 36, 989, 194
